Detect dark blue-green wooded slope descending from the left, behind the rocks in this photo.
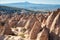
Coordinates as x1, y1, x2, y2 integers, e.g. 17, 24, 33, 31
0, 6, 34, 14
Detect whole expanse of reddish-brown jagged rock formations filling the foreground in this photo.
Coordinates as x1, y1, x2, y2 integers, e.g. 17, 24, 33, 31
0, 9, 60, 40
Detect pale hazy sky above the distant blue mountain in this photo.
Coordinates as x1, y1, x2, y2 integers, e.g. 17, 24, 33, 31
0, 0, 60, 4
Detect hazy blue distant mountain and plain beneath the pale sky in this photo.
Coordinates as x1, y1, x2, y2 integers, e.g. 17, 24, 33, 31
2, 2, 60, 10
